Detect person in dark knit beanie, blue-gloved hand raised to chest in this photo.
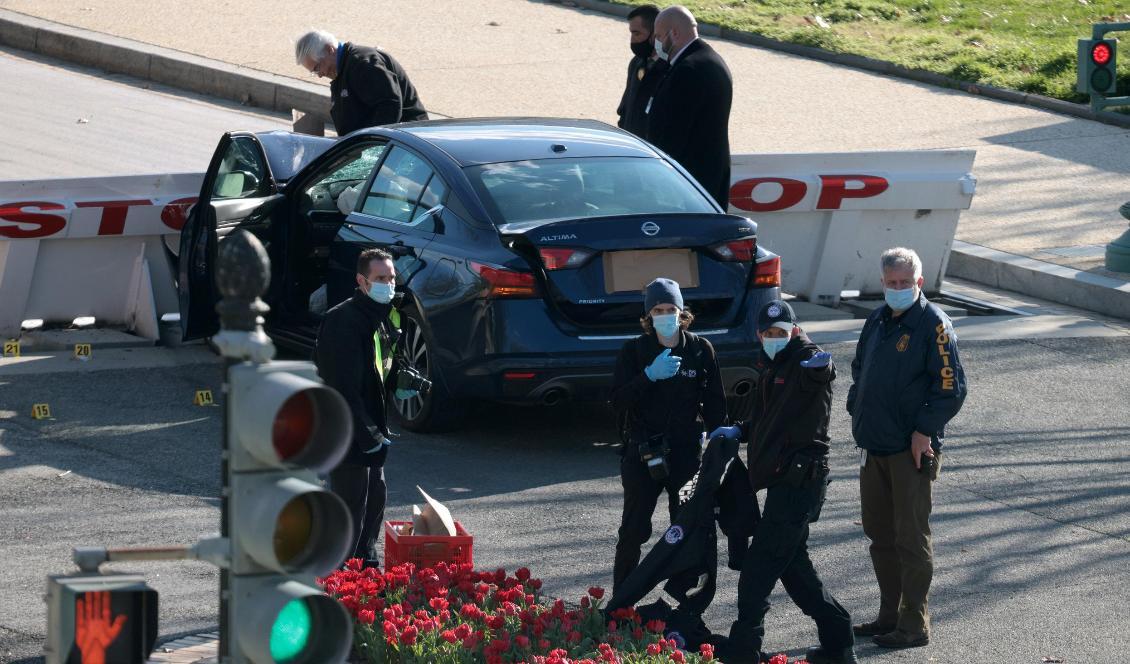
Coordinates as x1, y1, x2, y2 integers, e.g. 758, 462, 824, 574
611, 279, 725, 592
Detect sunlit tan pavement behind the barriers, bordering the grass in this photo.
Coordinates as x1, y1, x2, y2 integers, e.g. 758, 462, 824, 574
0, 0, 1130, 279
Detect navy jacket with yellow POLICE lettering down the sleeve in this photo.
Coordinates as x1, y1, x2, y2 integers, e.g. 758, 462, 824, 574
848, 295, 966, 454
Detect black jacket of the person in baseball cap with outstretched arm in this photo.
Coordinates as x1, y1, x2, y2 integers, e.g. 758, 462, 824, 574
738, 333, 836, 491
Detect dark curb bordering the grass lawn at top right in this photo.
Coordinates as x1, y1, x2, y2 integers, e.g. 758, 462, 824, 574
560, 0, 1130, 128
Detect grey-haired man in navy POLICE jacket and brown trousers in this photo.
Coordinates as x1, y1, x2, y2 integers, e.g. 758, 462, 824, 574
848, 247, 966, 648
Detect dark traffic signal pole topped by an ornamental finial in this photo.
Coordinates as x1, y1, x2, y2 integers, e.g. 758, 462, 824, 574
212, 230, 275, 663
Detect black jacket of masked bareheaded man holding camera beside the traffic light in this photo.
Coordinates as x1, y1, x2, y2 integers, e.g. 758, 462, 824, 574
314, 289, 399, 468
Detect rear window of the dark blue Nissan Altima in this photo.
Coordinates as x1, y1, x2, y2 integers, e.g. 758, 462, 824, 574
468, 157, 715, 224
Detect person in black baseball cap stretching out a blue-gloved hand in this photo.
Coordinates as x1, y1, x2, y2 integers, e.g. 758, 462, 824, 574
711, 300, 857, 664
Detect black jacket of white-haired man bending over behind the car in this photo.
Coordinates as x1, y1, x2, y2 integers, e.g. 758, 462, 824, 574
330, 42, 427, 136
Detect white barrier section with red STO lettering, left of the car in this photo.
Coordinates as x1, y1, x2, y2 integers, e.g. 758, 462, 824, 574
0, 173, 203, 339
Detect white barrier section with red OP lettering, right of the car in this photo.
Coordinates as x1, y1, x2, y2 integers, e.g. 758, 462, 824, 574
730, 150, 976, 305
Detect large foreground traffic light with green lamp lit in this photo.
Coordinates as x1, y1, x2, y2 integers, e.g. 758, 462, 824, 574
225, 361, 353, 664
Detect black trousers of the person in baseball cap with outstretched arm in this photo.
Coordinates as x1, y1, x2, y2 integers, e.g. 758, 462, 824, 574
724, 474, 855, 662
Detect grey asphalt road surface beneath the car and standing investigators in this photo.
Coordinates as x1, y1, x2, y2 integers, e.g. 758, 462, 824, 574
0, 338, 1130, 662
